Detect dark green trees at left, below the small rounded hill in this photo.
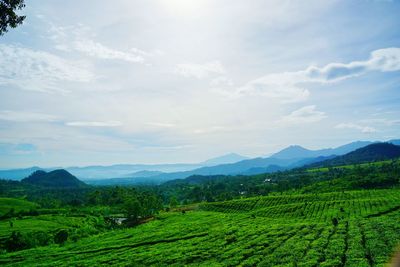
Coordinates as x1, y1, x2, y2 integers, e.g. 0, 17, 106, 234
0, 180, 165, 224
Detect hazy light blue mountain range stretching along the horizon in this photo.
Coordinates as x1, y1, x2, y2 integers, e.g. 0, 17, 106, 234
0, 140, 400, 184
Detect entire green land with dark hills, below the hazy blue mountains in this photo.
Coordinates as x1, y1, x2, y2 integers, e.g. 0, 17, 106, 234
0, 143, 400, 267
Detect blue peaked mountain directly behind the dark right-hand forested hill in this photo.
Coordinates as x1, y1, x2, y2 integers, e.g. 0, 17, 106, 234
271, 141, 373, 159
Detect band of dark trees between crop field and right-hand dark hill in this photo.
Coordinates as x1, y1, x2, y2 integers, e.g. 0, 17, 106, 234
160, 160, 400, 204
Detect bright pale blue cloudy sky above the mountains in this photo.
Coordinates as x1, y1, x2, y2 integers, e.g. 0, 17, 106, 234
0, 0, 400, 168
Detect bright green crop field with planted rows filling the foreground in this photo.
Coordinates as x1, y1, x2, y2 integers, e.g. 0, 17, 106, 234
0, 189, 400, 267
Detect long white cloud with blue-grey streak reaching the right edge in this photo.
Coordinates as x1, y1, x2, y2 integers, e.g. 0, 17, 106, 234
233, 47, 400, 102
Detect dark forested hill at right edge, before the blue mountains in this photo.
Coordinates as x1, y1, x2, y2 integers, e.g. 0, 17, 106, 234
306, 143, 400, 167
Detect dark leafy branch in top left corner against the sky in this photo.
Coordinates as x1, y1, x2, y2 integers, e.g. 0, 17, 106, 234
0, 0, 25, 36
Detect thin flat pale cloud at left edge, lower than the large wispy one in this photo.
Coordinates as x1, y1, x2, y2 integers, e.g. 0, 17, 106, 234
0, 110, 57, 122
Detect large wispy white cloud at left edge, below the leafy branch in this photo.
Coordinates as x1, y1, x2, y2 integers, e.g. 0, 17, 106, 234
0, 44, 95, 92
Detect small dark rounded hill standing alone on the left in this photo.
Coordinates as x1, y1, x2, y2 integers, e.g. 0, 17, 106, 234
21, 169, 87, 188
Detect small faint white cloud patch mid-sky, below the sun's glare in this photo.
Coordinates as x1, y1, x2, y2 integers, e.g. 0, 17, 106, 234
174, 61, 226, 79
